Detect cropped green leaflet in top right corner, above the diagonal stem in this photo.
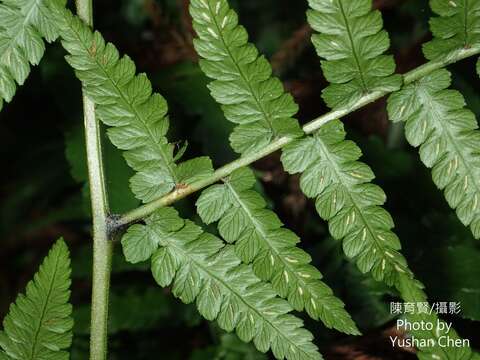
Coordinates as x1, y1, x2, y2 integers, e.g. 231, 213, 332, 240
423, 0, 480, 60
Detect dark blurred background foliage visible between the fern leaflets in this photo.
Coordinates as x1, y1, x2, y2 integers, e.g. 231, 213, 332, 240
0, 0, 480, 360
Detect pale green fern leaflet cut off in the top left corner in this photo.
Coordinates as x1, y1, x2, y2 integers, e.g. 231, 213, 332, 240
0, 0, 66, 110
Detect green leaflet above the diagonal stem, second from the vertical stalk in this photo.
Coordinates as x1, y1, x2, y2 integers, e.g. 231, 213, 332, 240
190, 0, 303, 153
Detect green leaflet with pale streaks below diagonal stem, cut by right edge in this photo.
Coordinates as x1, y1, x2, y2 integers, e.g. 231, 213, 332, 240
388, 70, 480, 239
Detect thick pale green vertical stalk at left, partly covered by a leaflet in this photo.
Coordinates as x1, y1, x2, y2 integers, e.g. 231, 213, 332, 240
76, 0, 113, 360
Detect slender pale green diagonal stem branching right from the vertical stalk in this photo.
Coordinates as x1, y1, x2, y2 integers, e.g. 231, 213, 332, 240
116, 47, 480, 226
